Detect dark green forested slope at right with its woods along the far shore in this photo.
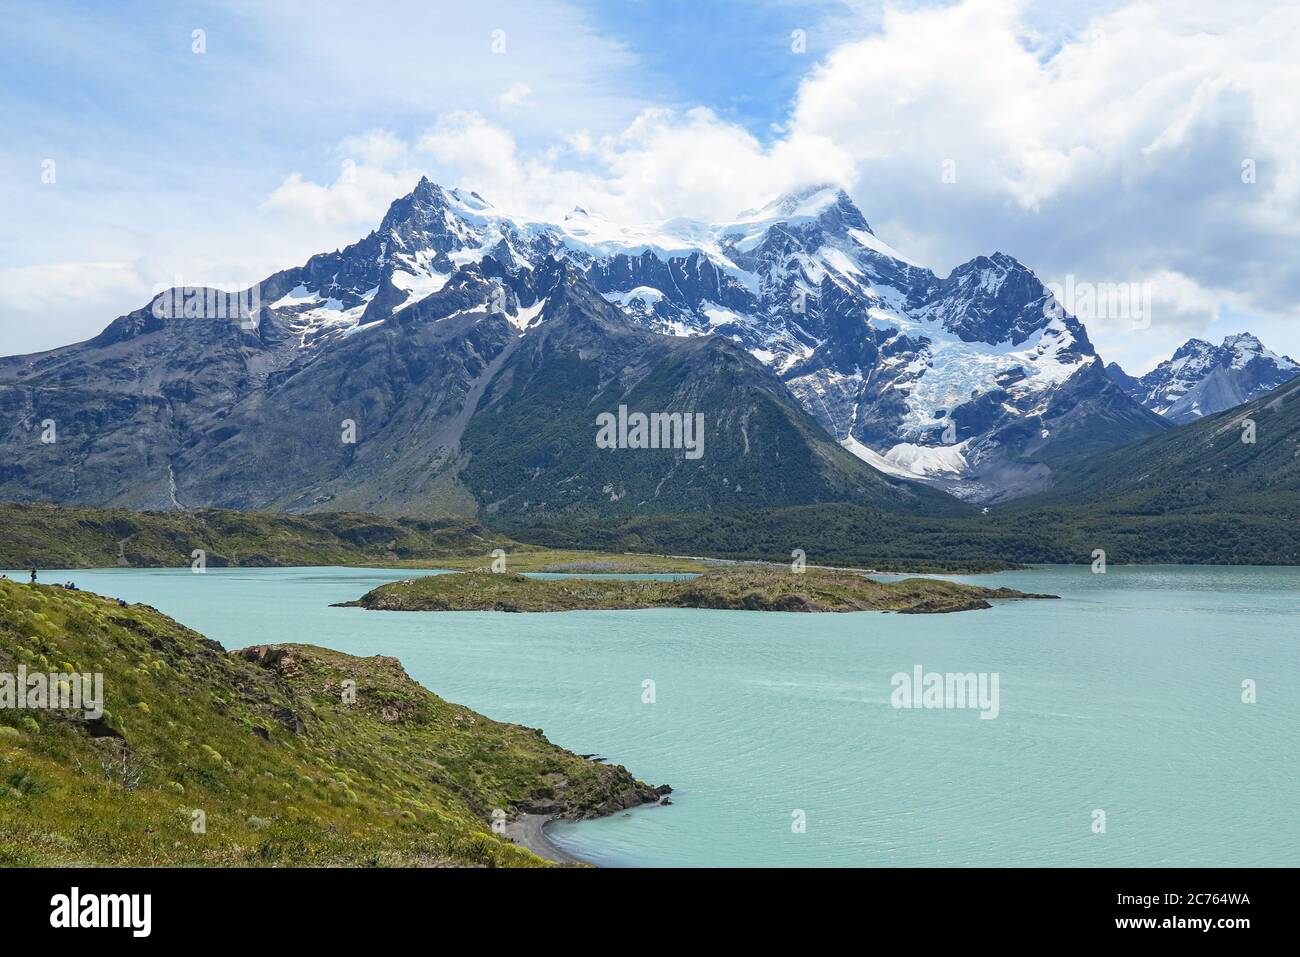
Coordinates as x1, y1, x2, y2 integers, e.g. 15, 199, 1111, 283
497, 380, 1300, 571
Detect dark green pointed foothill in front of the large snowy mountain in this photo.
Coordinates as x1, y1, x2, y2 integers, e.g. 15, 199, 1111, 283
462, 330, 971, 521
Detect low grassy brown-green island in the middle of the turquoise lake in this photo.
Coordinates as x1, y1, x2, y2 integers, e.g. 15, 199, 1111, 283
338, 568, 1057, 614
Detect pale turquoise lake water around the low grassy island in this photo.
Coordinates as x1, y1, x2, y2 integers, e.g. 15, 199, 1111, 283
9, 566, 1300, 866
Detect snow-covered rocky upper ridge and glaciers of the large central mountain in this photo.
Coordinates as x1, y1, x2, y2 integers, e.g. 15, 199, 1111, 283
250, 179, 1164, 501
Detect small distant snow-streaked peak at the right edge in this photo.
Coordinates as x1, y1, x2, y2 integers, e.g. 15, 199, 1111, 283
1106, 333, 1300, 423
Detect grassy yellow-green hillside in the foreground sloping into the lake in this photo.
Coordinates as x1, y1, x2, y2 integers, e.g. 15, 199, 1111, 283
0, 581, 658, 866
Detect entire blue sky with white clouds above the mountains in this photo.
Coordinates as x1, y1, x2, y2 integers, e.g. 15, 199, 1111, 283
0, 0, 1300, 369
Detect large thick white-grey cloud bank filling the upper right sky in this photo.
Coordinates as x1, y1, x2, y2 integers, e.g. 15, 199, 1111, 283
789, 0, 1300, 366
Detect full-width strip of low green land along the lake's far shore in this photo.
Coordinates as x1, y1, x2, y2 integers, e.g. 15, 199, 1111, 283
0, 490, 1300, 573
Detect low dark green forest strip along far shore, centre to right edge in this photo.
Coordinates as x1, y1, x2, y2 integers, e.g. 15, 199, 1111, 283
502, 497, 1300, 572
